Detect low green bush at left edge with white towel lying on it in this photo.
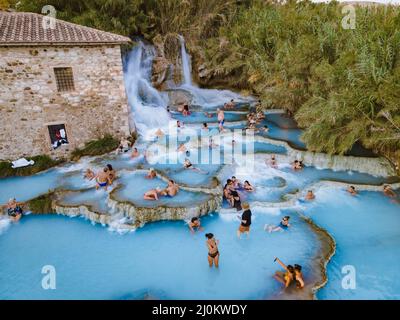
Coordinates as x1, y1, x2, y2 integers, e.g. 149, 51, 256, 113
0, 155, 64, 178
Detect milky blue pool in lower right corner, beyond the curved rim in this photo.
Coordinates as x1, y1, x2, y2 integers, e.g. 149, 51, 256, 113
305, 188, 400, 299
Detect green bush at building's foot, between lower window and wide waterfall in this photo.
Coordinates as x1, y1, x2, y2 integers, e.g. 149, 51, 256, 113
71, 135, 119, 161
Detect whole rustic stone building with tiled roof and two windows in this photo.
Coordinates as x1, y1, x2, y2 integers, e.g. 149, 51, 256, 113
0, 11, 134, 160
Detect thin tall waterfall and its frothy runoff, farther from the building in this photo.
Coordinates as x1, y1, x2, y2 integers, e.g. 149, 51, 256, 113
179, 36, 253, 108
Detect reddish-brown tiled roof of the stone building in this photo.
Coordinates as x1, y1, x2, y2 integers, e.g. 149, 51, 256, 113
0, 11, 130, 46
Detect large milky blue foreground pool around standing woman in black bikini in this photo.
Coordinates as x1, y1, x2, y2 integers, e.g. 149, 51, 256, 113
0, 211, 318, 299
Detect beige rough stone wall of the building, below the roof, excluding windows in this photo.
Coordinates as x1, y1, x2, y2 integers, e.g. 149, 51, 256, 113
0, 45, 130, 160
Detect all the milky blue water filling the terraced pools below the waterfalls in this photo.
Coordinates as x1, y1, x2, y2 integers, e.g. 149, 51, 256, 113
0, 104, 400, 299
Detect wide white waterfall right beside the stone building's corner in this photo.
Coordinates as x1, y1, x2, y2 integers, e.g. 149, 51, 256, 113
124, 42, 170, 136
